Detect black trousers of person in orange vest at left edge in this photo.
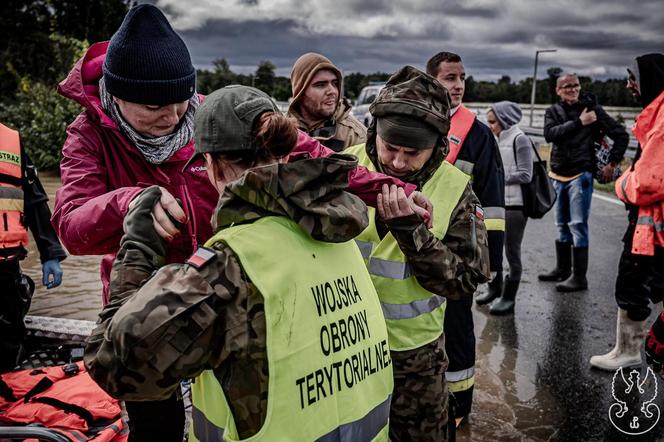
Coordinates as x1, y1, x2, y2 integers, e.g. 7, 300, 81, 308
0, 259, 35, 373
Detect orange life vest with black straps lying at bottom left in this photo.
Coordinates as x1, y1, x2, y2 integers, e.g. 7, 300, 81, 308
0, 362, 128, 442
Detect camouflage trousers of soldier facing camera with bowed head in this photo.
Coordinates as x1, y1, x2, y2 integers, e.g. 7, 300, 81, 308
390, 335, 449, 442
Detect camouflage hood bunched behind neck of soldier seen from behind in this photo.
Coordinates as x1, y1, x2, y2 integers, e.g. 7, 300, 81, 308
212, 154, 369, 242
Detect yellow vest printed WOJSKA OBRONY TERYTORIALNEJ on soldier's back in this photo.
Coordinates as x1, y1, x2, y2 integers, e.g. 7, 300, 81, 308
192, 217, 393, 441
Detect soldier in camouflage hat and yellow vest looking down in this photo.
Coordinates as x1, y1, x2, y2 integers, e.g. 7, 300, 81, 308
346, 66, 489, 441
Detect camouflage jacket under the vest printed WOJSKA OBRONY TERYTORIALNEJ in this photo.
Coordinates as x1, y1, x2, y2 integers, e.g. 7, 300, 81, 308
85, 155, 368, 438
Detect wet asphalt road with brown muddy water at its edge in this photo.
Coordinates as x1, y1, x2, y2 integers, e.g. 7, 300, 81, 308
458, 193, 664, 441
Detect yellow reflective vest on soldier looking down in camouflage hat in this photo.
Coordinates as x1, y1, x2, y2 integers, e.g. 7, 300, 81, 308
344, 145, 470, 351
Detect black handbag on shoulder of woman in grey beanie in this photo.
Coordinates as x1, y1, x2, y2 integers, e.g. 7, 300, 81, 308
512, 134, 557, 219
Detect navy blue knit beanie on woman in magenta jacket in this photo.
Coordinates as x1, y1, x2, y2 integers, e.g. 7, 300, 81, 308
103, 5, 196, 105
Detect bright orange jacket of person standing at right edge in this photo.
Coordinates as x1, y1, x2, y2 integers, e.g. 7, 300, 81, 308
615, 92, 664, 256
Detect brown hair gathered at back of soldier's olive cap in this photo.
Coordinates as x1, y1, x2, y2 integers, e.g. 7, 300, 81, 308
254, 112, 298, 159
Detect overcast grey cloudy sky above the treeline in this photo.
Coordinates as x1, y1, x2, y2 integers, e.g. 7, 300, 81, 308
156, 0, 664, 80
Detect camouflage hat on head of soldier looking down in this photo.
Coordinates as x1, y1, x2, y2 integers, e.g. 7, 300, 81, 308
369, 66, 450, 137
